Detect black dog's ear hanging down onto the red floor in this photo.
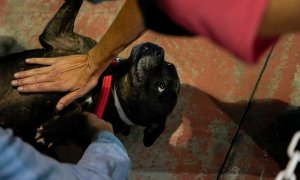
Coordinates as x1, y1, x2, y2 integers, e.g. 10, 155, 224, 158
143, 122, 165, 147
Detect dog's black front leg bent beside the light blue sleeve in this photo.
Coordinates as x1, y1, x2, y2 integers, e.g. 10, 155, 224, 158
36, 95, 93, 148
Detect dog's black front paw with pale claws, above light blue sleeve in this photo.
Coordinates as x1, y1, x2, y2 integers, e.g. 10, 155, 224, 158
35, 116, 67, 148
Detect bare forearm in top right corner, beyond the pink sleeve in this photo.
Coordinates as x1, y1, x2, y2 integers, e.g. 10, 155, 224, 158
258, 0, 300, 37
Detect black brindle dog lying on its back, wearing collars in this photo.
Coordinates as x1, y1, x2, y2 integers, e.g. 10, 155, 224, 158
0, 0, 180, 149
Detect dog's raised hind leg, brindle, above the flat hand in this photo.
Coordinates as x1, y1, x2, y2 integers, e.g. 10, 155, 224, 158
39, 0, 96, 53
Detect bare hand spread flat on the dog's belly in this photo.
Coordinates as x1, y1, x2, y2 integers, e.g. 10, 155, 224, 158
11, 55, 106, 110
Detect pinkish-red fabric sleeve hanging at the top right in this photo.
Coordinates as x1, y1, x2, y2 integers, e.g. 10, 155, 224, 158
157, 0, 277, 63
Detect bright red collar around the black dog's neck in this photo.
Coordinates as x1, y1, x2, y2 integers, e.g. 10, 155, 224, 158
94, 58, 119, 118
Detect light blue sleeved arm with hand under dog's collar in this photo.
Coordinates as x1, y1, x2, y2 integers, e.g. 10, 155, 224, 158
0, 114, 130, 180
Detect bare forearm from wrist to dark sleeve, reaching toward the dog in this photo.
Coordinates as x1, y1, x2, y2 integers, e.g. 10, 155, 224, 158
88, 0, 146, 69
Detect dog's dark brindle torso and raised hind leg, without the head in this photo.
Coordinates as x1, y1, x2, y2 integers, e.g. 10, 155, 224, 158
0, 0, 96, 140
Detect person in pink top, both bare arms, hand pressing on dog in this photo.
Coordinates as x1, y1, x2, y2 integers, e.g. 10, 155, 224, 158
12, 0, 300, 110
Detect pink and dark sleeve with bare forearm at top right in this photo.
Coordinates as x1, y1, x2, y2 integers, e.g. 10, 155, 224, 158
139, 0, 300, 63
